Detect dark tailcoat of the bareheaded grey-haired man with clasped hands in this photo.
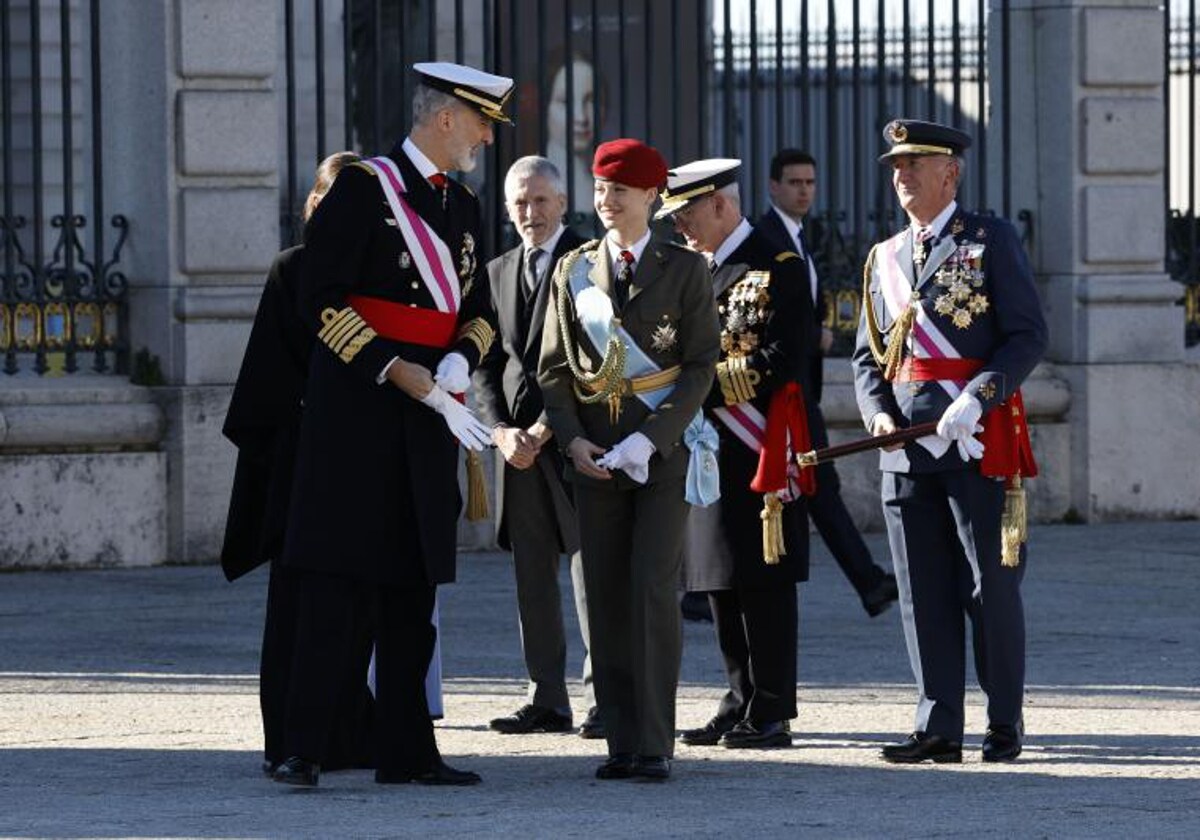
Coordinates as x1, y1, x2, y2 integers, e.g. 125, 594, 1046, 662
474, 228, 583, 553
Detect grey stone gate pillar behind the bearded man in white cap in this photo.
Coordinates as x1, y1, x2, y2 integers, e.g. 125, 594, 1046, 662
102, 0, 280, 562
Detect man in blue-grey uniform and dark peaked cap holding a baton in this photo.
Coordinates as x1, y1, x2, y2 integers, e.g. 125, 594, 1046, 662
852, 120, 1046, 763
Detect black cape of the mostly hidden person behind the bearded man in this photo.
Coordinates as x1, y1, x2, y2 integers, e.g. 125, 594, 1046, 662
221, 246, 313, 581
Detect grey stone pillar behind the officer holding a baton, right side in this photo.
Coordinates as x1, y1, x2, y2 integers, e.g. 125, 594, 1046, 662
990, 0, 1200, 521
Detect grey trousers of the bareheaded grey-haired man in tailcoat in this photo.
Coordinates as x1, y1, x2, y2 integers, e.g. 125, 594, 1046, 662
504, 462, 596, 710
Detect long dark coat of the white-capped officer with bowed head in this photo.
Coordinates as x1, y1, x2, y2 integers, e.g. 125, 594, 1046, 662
686, 230, 815, 590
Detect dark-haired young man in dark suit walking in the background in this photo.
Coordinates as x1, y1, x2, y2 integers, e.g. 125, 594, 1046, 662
755, 149, 896, 618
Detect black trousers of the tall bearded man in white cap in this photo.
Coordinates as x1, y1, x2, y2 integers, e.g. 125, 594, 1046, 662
284, 570, 440, 774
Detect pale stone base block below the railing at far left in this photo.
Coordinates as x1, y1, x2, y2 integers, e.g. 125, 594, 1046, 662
0, 452, 167, 569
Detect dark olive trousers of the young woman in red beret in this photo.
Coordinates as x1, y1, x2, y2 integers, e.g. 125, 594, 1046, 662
575, 478, 689, 757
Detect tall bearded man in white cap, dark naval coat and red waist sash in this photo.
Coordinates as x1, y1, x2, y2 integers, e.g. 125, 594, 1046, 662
275, 64, 512, 786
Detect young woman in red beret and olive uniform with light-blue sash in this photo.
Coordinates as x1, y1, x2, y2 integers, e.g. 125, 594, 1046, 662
538, 139, 719, 781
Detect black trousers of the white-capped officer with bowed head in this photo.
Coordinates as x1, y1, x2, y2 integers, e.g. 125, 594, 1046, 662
708, 583, 799, 724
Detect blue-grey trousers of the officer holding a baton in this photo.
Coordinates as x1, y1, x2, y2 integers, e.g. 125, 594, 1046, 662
882, 468, 1026, 740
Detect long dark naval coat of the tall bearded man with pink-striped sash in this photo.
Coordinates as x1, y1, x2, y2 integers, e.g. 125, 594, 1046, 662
283, 146, 494, 584
